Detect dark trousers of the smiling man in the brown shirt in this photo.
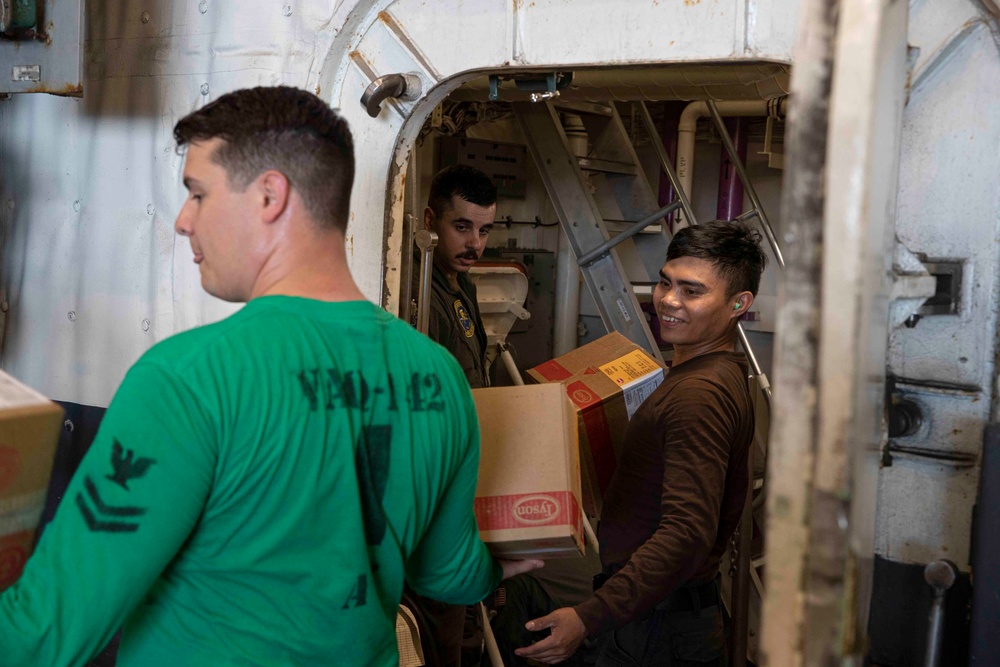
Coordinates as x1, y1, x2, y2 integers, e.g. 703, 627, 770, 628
597, 589, 728, 667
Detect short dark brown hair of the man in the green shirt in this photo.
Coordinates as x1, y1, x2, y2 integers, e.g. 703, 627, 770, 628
174, 86, 354, 231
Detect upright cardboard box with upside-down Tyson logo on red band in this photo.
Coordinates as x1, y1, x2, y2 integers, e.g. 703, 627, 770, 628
472, 385, 584, 558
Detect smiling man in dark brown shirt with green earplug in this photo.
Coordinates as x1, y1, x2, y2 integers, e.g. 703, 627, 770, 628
518, 222, 767, 666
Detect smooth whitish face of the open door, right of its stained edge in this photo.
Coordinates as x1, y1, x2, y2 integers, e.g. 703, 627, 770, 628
806, 0, 908, 664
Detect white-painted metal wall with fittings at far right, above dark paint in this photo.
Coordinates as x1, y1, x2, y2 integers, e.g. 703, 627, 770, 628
876, 0, 1000, 571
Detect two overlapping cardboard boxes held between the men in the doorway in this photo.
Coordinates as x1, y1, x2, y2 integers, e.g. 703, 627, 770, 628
473, 333, 664, 558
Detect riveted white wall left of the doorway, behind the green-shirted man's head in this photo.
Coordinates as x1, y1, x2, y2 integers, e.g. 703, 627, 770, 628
0, 0, 346, 406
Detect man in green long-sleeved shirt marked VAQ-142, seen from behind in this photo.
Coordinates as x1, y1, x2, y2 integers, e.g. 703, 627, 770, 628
0, 87, 539, 667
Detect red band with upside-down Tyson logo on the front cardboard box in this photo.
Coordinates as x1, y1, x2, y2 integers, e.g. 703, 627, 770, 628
474, 491, 583, 534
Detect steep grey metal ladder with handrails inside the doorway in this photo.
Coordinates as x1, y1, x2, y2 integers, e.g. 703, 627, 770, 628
513, 96, 785, 656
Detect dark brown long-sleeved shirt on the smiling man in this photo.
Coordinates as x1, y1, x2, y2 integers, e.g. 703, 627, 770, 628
574, 352, 754, 635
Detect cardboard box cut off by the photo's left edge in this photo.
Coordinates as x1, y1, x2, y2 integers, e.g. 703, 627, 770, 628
0, 371, 63, 591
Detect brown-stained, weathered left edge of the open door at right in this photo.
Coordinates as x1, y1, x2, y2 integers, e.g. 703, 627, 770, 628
760, 0, 836, 667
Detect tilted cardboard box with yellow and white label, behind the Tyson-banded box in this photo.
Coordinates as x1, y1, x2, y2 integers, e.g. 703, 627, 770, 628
528, 332, 664, 516
